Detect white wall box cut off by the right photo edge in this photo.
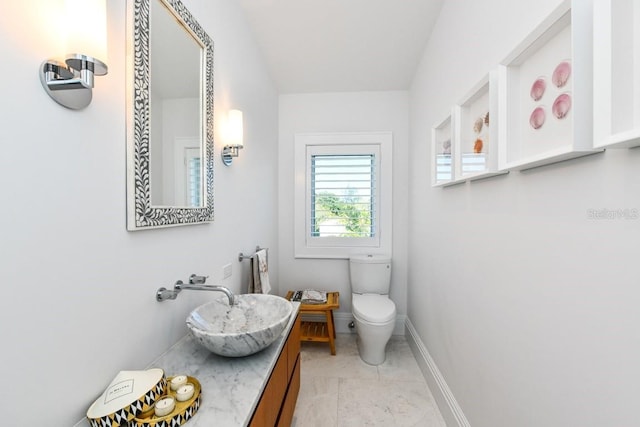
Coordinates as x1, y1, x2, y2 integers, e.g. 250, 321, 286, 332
593, 0, 640, 148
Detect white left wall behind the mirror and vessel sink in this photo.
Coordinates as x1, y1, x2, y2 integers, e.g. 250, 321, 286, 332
0, 0, 278, 426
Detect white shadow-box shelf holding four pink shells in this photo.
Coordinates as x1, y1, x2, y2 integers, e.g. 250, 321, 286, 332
497, 0, 602, 171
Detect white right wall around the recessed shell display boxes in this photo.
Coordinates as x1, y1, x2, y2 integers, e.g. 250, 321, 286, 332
408, 0, 640, 427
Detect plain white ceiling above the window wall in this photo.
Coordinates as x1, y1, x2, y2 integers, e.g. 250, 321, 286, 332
239, 0, 444, 93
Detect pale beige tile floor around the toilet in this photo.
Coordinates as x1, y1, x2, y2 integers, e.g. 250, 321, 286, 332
291, 334, 446, 427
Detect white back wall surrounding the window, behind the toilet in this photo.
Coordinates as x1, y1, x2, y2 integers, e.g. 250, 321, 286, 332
278, 91, 409, 330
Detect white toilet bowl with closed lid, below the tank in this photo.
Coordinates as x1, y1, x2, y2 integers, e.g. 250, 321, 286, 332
352, 294, 396, 365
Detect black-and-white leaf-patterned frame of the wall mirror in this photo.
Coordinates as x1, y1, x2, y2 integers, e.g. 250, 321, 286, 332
127, 0, 214, 231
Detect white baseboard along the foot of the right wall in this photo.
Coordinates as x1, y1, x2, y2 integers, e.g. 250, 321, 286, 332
405, 319, 471, 427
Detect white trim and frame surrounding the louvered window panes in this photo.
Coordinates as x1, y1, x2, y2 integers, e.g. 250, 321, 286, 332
294, 132, 393, 259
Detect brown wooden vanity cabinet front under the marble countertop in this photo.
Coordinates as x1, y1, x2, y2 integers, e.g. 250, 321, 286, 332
249, 315, 300, 427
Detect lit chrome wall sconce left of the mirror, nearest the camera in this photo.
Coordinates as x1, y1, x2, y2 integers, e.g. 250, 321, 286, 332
40, 0, 108, 110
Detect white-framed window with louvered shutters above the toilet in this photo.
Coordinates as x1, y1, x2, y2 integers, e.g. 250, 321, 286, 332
294, 132, 392, 258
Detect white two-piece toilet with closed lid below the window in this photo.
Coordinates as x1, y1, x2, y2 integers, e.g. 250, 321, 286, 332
349, 255, 396, 365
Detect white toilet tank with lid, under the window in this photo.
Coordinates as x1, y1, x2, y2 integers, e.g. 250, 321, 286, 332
349, 255, 391, 295
